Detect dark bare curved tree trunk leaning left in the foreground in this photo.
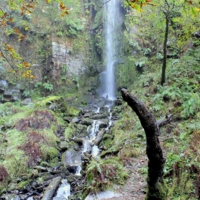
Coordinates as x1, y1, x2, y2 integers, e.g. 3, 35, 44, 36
121, 89, 167, 200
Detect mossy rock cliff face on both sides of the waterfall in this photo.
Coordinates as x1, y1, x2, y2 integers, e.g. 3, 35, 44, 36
0, 0, 138, 99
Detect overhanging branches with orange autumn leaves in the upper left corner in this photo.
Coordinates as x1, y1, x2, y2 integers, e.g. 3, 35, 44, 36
0, 0, 69, 78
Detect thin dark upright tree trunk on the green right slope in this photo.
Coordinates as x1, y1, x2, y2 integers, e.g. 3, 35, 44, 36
161, 12, 169, 85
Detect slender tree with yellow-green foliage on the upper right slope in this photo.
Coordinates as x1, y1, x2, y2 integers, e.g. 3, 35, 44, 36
126, 0, 200, 85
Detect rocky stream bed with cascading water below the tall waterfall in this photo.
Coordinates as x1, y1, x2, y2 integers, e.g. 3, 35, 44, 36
0, 99, 121, 200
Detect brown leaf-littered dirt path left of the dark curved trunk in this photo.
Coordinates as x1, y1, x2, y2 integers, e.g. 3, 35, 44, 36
102, 155, 147, 200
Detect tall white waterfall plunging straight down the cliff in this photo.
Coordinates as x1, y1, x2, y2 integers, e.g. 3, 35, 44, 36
100, 0, 120, 100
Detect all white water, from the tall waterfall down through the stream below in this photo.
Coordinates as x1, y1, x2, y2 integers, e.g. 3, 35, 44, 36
1, 0, 120, 200
